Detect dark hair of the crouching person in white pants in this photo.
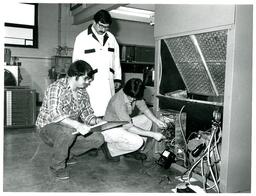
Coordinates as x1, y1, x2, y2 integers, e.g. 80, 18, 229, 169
123, 78, 145, 100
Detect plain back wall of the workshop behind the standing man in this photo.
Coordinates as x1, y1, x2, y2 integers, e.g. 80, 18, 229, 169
8, 3, 154, 100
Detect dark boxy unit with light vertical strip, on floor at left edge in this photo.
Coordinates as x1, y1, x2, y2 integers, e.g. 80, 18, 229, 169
4, 87, 36, 128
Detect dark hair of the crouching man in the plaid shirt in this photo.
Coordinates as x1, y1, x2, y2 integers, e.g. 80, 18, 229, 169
68, 60, 97, 78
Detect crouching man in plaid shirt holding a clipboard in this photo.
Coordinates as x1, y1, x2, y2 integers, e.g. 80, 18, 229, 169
36, 60, 104, 179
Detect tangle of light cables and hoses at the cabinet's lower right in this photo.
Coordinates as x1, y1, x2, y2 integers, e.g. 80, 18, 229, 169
178, 109, 222, 193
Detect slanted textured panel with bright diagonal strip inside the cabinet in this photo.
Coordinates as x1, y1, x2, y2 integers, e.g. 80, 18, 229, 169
164, 30, 227, 96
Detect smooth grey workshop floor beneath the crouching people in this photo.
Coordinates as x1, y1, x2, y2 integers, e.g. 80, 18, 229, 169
3, 129, 181, 193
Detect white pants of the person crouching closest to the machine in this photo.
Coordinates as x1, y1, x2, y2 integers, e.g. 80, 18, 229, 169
102, 115, 152, 157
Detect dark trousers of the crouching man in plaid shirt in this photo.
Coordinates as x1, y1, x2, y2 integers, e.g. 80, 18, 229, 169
38, 123, 104, 169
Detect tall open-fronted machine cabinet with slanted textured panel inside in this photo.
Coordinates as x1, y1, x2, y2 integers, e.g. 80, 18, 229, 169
154, 4, 253, 193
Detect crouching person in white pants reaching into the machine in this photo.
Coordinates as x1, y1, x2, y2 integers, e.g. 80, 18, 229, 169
102, 78, 167, 161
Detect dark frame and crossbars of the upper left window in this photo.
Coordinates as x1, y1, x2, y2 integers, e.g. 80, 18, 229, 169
4, 3, 38, 48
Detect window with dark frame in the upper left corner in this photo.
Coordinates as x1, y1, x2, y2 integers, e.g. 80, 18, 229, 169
5, 3, 38, 48
